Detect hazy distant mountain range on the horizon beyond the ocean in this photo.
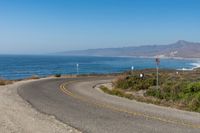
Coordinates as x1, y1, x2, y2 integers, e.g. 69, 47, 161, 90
60, 40, 200, 58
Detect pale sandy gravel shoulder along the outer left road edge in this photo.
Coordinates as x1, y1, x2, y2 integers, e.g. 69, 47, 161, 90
0, 79, 79, 133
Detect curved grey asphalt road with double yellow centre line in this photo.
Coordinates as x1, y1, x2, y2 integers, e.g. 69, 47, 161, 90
18, 77, 200, 133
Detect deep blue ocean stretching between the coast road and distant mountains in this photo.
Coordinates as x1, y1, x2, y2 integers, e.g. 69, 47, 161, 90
0, 55, 200, 80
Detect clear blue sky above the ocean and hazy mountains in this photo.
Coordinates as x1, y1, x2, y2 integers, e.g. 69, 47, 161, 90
0, 0, 200, 54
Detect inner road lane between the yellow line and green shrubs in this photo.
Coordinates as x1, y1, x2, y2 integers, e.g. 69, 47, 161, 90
68, 80, 200, 127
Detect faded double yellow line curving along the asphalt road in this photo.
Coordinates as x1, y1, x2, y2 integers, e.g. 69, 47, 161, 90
60, 82, 200, 129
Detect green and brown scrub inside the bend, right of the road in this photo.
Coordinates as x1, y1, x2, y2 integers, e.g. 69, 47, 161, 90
101, 69, 200, 112
